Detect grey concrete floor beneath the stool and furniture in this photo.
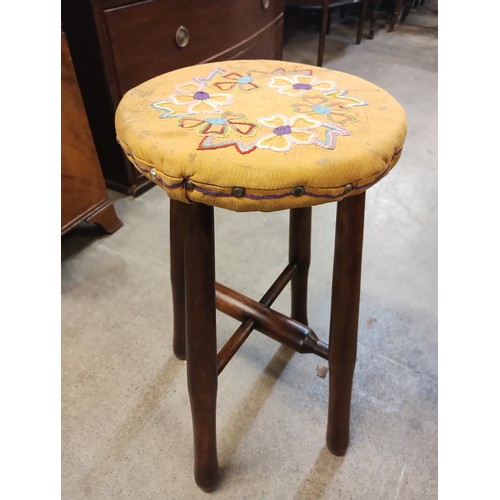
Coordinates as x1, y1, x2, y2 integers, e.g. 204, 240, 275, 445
62, 8, 437, 500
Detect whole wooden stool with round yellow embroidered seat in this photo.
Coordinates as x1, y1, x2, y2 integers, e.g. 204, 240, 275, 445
116, 60, 406, 491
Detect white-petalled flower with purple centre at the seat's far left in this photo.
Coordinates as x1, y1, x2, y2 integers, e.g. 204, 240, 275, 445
152, 82, 233, 118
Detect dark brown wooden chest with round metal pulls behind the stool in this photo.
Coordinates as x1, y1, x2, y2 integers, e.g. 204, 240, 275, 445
61, 0, 284, 195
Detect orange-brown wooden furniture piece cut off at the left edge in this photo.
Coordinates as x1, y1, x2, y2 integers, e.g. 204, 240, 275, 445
61, 34, 122, 234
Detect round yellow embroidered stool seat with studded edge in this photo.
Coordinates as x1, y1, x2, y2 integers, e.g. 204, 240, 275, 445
116, 60, 406, 211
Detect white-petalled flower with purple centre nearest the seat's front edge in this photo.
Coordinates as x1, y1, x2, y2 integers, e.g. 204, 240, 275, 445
257, 115, 321, 151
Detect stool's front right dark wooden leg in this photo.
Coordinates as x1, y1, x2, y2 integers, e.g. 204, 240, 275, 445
326, 193, 365, 455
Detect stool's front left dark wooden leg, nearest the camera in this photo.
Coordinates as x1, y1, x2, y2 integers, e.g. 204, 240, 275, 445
184, 203, 219, 491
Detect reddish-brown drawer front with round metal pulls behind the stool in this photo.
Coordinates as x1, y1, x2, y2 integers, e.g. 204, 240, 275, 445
93, 0, 284, 102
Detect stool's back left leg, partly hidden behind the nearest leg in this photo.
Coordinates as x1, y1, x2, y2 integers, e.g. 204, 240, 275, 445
170, 200, 189, 359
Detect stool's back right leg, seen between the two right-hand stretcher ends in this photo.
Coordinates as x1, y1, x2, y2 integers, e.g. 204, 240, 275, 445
289, 207, 312, 325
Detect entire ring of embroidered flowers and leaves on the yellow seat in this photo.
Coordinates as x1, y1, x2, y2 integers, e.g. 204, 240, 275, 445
152, 68, 367, 154
